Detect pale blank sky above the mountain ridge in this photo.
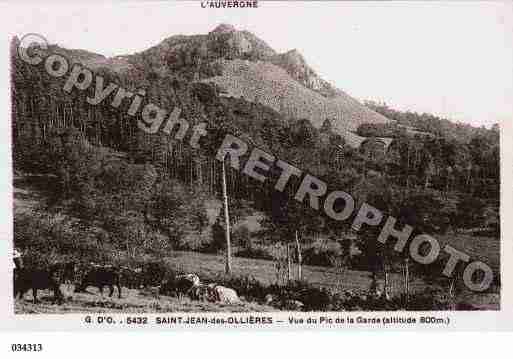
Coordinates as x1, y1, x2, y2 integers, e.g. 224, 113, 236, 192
4, 1, 513, 127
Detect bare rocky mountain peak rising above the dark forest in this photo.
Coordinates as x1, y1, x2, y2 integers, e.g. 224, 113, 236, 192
45, 24, 390, 142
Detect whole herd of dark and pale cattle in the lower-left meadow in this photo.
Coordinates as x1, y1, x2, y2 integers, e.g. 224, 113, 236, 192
14, 261, 239, 304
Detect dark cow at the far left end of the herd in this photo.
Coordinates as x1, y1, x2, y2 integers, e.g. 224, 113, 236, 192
14, 263, 64, 303
